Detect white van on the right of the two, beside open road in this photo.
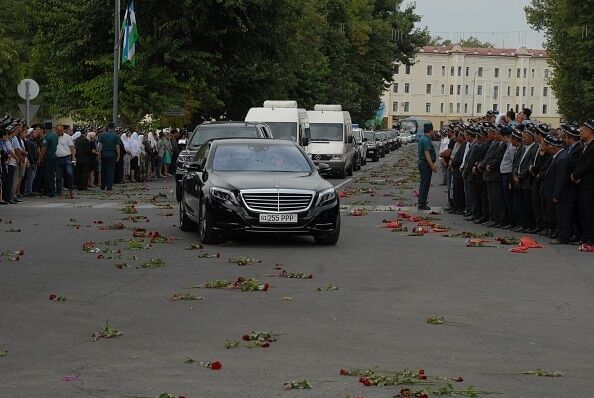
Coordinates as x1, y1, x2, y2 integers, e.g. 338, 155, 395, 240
307, 105, 356, 178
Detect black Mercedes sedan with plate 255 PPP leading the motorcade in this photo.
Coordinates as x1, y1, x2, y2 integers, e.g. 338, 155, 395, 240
179, 139, 340, 245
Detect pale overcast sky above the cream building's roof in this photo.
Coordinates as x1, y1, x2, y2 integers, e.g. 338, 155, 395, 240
409, 0, 544, 48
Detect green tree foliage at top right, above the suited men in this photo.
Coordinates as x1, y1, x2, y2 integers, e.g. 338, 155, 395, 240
525, 0, 594, 121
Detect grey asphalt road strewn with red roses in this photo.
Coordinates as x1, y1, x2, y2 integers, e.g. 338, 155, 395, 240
0, 145, 594, 398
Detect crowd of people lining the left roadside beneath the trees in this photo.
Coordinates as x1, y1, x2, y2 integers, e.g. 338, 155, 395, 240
0, 116, 185, 205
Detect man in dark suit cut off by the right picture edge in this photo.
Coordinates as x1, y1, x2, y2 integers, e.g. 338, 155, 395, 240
571, 119, 594, 244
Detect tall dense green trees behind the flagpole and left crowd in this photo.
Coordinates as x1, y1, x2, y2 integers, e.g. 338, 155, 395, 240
0, 0, 428, 124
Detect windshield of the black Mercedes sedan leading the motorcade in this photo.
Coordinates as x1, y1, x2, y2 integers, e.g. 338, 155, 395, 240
212, 144, 312, 173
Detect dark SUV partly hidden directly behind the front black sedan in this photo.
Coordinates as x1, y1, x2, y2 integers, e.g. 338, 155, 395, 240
175, 122, 272, 201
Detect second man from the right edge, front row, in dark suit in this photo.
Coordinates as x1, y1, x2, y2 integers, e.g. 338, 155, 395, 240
543, 135, 577, 244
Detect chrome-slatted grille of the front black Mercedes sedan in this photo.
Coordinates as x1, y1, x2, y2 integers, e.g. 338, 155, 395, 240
241, 189, 315, 213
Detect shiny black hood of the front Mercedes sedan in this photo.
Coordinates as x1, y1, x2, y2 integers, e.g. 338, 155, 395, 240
209, 172, 333, 191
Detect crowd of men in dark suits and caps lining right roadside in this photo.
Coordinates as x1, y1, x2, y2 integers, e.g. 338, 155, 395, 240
419, 109, 594, 245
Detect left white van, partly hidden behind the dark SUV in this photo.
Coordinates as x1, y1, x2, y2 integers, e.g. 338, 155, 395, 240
245, 101, 310, 148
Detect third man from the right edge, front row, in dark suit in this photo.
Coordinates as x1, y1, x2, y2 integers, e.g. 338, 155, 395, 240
516, 128, 539, 233
